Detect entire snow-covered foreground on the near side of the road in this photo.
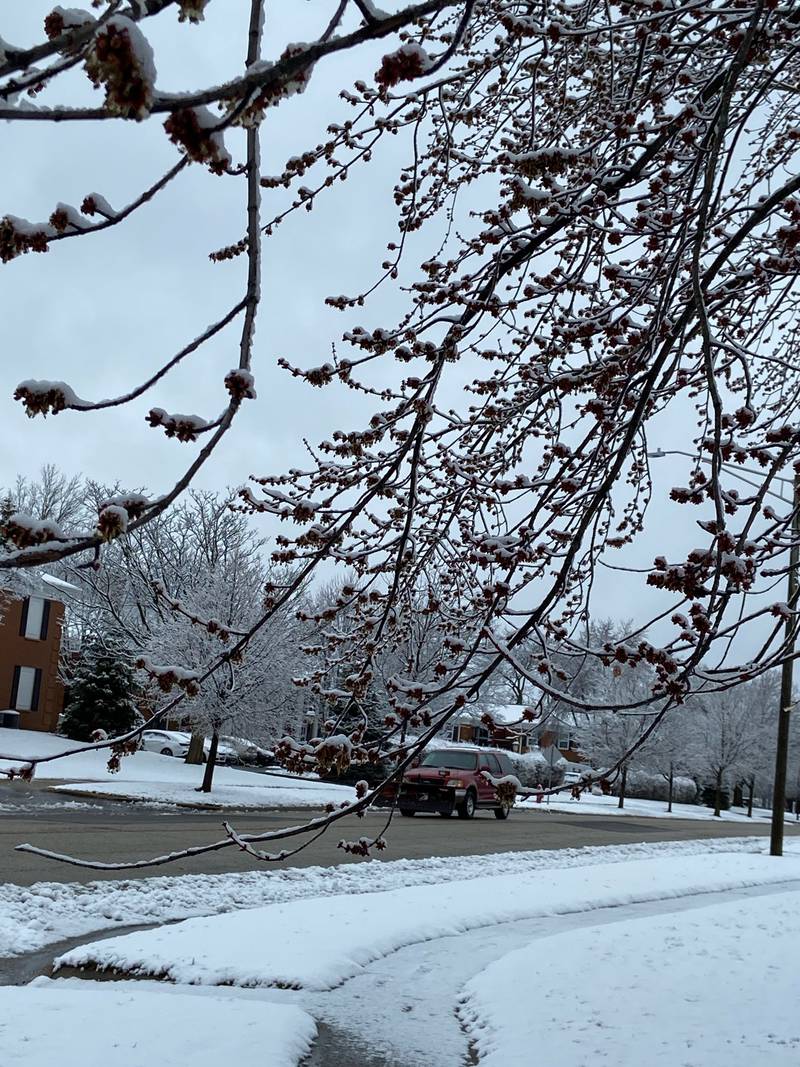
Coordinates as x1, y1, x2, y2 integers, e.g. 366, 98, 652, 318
0, 838, 800, 1067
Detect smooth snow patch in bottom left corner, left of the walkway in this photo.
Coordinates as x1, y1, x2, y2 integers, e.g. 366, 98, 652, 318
0, 978, 317, 1067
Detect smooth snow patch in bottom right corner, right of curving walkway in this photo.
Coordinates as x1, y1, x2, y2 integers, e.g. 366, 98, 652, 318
461, 892, 800, 1067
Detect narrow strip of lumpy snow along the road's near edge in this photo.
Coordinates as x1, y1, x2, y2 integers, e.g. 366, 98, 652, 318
0, 838, 776, 958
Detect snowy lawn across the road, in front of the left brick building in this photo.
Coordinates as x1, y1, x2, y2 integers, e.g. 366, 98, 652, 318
0, 728, 355, 808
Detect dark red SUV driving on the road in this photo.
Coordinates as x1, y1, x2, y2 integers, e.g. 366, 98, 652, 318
375, 748, 513, 818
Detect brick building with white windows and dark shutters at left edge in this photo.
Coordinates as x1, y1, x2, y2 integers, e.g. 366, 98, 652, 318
0, 582, 64, 732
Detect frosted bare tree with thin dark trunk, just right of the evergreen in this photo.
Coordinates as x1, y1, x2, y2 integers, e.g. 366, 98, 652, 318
61, 492, 305, 792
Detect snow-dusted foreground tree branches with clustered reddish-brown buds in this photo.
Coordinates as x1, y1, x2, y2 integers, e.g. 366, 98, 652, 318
0, 0, 800, 859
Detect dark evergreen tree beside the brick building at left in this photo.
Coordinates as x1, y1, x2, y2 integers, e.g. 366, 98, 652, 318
61, 639, 139, 740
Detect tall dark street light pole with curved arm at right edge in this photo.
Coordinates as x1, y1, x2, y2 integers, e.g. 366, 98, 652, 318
647, 448, 800, 856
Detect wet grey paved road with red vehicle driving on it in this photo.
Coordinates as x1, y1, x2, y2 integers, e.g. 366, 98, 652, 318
0, 783, 800, 886
